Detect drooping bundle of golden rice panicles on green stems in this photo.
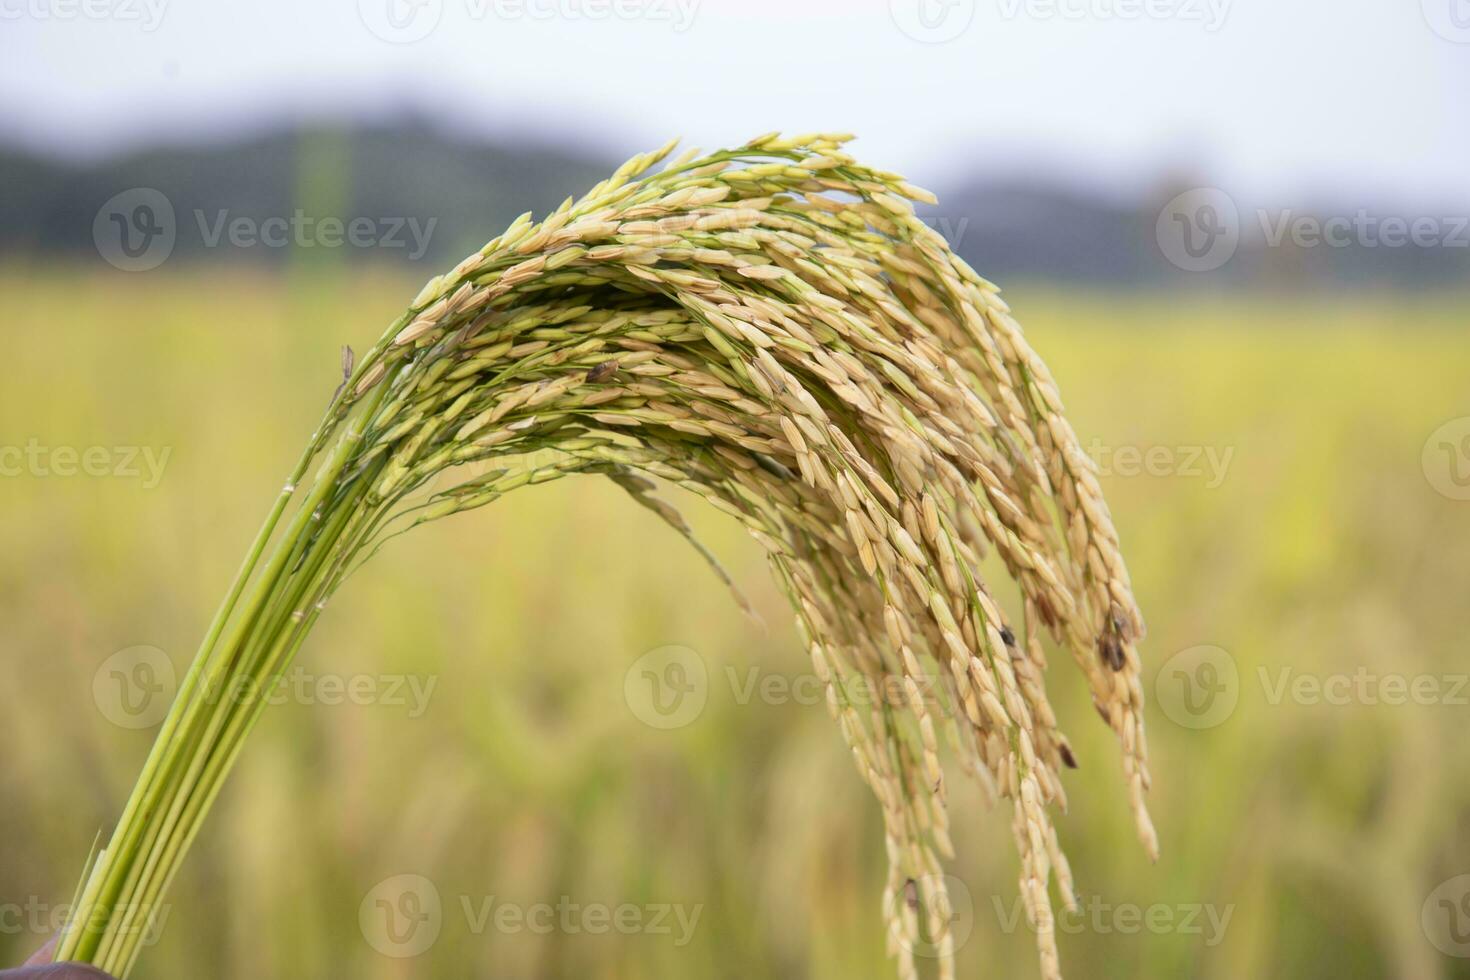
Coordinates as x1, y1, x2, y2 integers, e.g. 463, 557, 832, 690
57, 134, 1157, 979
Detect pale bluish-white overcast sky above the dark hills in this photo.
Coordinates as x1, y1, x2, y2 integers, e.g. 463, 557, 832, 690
0, 0, 1470, 206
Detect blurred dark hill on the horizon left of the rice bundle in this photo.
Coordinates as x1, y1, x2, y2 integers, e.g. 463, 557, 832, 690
0, 123, 616, 264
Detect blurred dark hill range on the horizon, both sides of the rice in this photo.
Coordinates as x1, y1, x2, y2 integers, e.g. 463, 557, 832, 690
0, 120, 1470, 288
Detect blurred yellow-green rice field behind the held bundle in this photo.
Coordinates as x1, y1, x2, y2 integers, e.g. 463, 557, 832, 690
0, 253, 1470, 980
